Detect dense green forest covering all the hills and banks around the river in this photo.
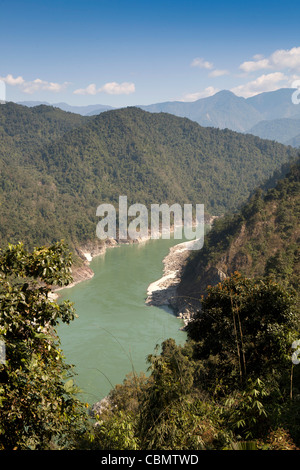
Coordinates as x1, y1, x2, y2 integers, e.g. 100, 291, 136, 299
0, 103, 300, 450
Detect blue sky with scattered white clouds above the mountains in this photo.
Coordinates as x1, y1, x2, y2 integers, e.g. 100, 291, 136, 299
0, 0, 300, 107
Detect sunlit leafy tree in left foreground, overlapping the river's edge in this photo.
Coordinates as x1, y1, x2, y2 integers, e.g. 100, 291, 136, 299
0, 242, 87, 449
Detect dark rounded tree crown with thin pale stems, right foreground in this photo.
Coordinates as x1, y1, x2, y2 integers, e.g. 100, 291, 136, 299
187, 273, 299, 386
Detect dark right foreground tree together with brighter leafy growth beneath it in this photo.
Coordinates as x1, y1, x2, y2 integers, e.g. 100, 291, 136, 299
187, 273, 300, 444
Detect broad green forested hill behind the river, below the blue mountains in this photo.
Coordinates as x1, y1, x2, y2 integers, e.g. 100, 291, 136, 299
0, 103, 297, 252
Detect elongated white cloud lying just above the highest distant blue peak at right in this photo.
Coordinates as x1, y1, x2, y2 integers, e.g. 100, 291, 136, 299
231, 72, 289, 98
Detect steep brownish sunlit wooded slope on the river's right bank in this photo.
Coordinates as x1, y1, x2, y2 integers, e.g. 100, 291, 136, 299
178, 160, 300, 318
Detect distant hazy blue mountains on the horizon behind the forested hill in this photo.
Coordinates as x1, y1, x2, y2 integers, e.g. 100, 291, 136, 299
19, 88, 300, 147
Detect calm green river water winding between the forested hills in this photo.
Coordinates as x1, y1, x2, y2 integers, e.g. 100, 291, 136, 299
57, 239, 186, 404
